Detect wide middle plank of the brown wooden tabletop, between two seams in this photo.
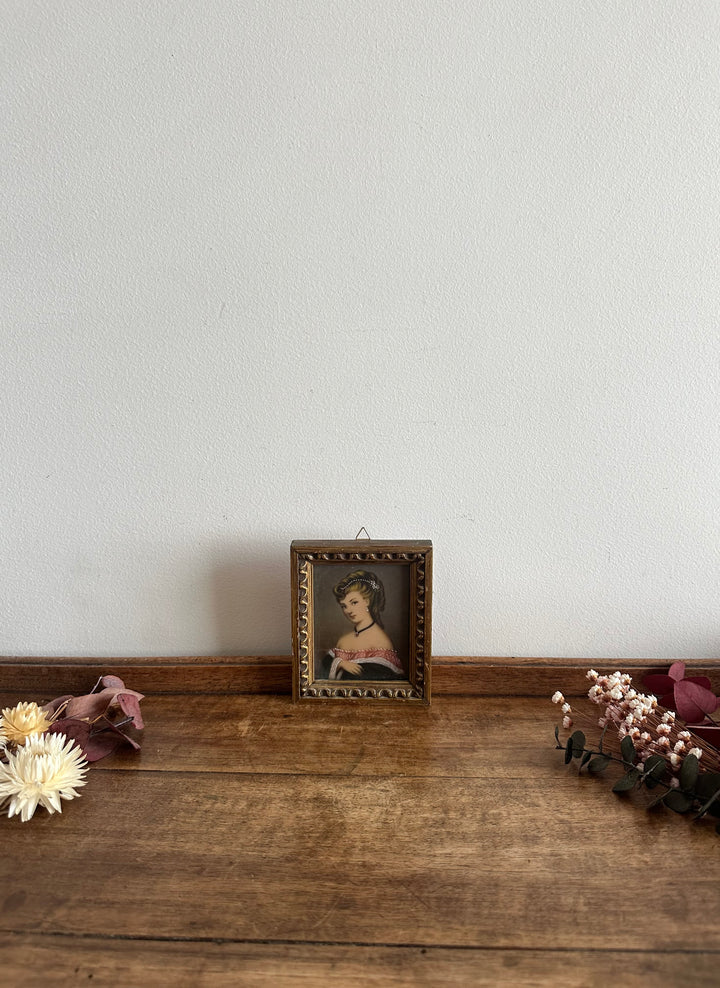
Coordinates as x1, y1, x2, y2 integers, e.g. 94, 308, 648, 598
0, 772, 720, 950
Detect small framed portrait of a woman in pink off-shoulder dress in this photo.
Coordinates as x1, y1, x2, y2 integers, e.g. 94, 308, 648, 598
290, 540, 432, 703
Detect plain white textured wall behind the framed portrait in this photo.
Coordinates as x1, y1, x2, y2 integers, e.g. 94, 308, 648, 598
0, 0, 720, 658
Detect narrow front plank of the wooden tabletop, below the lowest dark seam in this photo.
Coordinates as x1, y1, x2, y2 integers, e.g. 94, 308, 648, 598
0, 934, 720, 988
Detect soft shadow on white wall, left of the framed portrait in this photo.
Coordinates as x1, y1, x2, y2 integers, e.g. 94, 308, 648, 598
211, 542, 292, 655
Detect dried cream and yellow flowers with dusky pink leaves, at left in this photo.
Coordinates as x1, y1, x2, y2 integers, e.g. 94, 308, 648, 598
0, 676, 145, 822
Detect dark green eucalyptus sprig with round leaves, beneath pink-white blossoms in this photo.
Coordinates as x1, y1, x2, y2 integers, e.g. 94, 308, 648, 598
555, 727, 720, 834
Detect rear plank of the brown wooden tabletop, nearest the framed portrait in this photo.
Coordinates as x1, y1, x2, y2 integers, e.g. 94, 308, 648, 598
0, 693, 572, 778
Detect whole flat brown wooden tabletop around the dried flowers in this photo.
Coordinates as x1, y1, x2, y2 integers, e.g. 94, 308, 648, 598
0, 670, 720, 988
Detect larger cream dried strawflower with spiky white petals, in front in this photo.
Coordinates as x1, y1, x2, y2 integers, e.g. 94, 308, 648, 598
0, 734, 88, 823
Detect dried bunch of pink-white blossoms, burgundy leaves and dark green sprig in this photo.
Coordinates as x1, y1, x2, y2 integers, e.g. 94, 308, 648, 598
552, 662, 720, 834
